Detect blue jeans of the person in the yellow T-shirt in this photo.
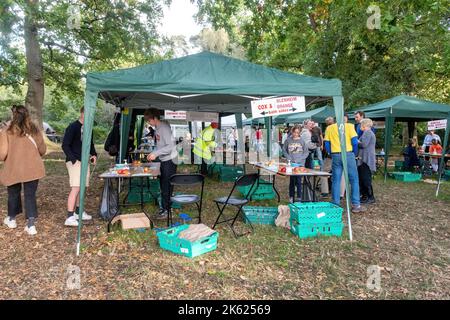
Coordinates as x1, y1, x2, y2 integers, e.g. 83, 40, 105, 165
331, 152, 360, 206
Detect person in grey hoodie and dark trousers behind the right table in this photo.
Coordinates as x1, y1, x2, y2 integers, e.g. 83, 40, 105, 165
283, 125, 309, 203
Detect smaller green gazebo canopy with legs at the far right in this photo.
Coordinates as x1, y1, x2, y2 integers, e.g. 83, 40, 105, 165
350, 95, 450, 190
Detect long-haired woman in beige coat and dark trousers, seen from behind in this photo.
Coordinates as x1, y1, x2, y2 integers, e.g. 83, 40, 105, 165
0, 106, 46, 235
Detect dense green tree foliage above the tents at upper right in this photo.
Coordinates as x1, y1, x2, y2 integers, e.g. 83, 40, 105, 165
197, 0, 450, 109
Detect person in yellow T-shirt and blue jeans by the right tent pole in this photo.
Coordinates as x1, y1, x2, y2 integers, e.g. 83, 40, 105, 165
324, 117, 365, 213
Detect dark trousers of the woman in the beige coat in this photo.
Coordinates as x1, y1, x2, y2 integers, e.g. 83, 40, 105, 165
8, 180, 39, 219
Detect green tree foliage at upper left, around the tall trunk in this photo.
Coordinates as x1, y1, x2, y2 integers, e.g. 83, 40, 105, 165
0, 0, 170, 121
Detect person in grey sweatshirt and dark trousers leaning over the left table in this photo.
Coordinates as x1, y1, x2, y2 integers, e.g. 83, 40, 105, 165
144, 109, 177, 219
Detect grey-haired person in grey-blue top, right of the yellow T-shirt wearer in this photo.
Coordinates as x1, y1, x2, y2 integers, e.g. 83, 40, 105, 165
358, 119, 377, 204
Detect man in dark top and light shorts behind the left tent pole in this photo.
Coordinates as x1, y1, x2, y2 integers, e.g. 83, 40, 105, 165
62, 107, 97, 227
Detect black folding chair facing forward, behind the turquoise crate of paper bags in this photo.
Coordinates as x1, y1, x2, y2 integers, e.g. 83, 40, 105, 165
167, 173, 205, 227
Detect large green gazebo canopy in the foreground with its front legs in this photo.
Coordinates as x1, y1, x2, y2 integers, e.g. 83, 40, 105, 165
77, 52, 352, 253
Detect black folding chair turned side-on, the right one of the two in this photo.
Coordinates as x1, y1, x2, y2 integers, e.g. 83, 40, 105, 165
213, 173, 259, 238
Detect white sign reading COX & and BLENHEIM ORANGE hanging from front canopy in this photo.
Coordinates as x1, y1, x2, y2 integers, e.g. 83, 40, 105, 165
251, 96, 306, 118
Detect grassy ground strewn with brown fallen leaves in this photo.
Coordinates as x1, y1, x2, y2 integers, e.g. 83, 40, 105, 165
0, 153, 450, 299
